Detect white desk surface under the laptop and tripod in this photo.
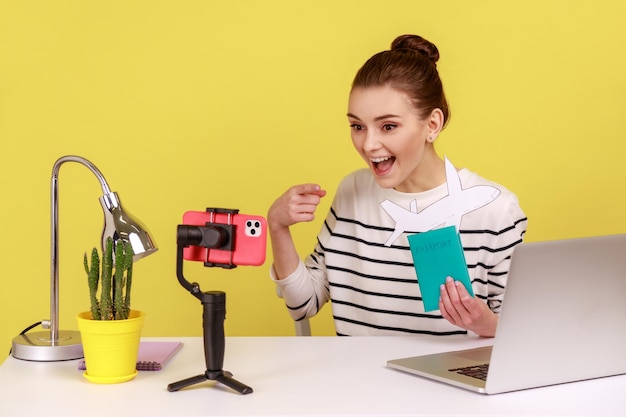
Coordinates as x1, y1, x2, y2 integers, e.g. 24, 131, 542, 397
0, 337, 626, 417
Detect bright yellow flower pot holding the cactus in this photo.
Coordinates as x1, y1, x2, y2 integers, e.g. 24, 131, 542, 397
76, 310, 144, 384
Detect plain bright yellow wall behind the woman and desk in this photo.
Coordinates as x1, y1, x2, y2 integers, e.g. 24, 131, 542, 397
0, 0, 626, 360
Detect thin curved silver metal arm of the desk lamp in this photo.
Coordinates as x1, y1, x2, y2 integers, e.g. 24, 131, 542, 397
49, 155, 111, 346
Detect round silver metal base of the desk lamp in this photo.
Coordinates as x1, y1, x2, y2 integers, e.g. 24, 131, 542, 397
11, 330, 83, 362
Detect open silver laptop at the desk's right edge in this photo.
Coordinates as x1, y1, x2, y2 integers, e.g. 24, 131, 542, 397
387, 234, 626, 394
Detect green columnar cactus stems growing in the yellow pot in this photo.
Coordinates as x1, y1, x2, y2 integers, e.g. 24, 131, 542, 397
83, 238, 133, 320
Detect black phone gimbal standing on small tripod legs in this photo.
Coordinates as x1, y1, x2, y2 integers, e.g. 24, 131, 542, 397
167, 211, 252, 394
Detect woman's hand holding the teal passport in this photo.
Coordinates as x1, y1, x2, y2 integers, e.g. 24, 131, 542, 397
439, 277, 498, 337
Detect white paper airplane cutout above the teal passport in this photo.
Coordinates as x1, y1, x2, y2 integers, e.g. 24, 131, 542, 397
380, 158, 500, 246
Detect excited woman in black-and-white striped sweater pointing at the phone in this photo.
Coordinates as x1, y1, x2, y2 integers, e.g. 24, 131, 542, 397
267, 35, 527, 337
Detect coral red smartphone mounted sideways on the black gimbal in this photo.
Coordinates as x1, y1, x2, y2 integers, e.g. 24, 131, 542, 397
183, 209, 267, 267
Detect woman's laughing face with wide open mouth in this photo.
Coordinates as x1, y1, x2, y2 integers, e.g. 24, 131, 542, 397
348, 86, 440, 192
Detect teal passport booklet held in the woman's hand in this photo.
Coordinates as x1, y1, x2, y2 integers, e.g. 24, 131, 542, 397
408, 226, 474, 311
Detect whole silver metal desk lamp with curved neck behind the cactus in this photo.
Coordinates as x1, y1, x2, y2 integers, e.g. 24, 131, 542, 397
12, 155, 157, 362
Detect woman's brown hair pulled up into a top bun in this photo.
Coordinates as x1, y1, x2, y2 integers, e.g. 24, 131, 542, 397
352, 35, 450, 126
